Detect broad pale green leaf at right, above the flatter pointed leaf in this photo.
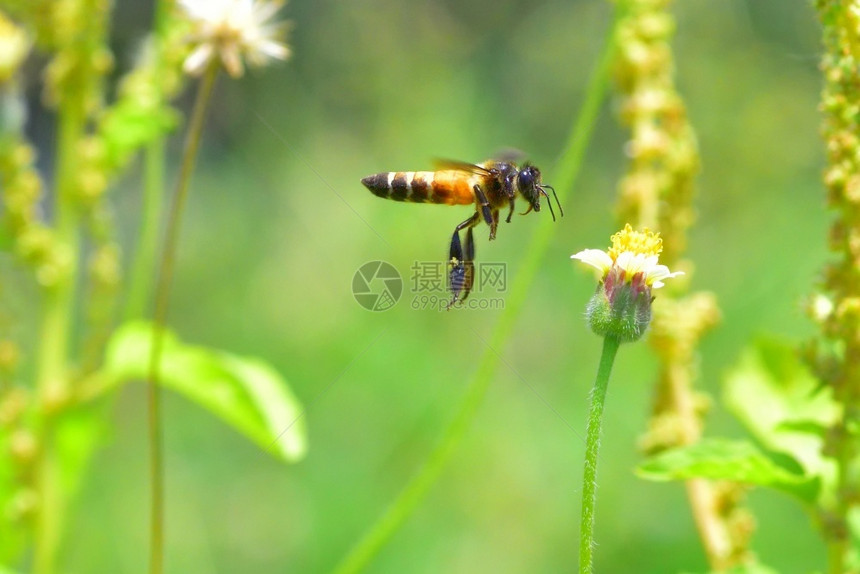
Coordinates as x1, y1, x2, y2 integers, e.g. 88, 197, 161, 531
723, 340, 839, 484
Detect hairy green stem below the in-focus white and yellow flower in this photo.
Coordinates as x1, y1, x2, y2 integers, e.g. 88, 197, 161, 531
579, 337, 619, 574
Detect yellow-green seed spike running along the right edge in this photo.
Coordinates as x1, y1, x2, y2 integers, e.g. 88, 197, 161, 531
804, 0, 860, 572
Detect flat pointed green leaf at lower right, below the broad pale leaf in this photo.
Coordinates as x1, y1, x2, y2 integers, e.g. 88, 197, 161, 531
636, 439, 819, 503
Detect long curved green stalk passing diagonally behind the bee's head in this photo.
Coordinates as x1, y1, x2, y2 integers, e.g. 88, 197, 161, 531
334, 10, 617, 574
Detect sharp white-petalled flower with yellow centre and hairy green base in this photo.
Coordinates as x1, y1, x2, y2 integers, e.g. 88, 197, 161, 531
571, 223, 683, 341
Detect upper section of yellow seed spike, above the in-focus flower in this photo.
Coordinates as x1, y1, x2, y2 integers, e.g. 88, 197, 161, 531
616, 0, 699, 268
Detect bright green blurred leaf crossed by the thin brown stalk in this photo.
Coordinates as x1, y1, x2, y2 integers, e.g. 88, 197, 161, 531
102, 322, 307, 461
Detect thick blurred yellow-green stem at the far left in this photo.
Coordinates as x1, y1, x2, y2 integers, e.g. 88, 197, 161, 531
33, 92, 86, 574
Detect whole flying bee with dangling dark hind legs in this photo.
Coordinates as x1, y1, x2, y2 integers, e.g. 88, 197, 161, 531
361, 160, 564, 309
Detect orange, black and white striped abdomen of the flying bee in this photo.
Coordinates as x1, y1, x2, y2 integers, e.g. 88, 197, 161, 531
361, 171, 474, 205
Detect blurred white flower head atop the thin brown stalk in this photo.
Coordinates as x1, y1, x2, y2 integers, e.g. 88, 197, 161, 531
179, 0, 290, 78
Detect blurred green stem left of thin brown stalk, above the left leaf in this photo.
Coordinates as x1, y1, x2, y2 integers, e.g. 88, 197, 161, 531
123, 137, 165, 321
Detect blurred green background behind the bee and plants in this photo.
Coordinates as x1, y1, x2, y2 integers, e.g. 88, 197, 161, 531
48, 0, 828, 573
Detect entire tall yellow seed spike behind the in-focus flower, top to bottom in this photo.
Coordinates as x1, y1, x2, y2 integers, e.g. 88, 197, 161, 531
610, 0, 750, 571
